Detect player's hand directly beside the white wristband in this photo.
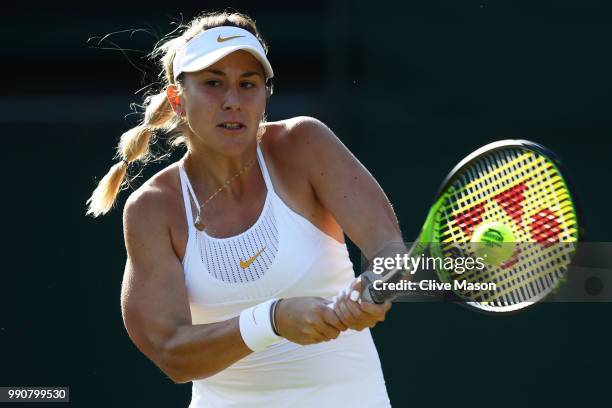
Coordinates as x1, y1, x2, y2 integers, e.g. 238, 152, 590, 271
276, 297, 347, 345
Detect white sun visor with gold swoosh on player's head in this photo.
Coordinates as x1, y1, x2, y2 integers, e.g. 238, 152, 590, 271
172, 26, 274, 81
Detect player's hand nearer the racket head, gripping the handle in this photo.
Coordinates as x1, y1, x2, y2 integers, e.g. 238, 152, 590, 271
334, 278, 391, 331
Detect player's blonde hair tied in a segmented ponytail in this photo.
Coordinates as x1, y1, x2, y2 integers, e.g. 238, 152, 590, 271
87, 12, 272, 217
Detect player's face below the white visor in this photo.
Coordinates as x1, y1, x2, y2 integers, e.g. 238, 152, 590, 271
168, 50, 266, 155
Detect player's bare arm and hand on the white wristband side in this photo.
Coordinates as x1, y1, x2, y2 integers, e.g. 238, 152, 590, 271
121, 187, 346, 383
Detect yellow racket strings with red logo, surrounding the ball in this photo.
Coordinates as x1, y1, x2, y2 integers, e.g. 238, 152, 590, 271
437, 148, 578, 307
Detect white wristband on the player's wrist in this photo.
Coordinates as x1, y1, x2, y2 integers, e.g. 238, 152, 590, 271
239, 299, 282, 351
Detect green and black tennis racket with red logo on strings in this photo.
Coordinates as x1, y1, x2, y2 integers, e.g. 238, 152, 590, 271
361, 140, 581, 312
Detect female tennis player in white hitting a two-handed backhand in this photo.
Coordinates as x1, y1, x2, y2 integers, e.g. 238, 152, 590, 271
88, 13, 401, 407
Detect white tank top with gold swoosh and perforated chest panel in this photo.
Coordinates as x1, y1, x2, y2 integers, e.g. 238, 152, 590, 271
179, 146, 389, 408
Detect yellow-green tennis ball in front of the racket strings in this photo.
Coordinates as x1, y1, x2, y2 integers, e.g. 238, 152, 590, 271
471, 222, 516, 266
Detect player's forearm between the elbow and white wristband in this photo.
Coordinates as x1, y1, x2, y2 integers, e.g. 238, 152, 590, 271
161, 317, 252, 383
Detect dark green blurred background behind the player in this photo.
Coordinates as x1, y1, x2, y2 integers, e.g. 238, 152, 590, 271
0, 0, 612, 407
